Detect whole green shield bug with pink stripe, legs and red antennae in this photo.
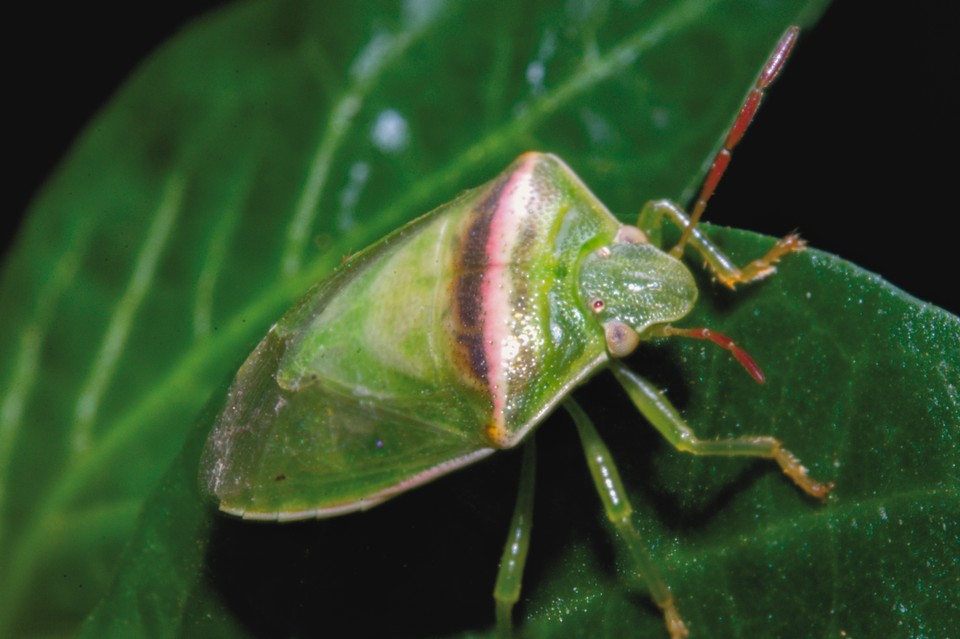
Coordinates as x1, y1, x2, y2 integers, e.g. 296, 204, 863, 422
200, 28, 832, 638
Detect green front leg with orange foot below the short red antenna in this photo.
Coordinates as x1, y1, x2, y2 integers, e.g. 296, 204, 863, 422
610, 360, 833, 499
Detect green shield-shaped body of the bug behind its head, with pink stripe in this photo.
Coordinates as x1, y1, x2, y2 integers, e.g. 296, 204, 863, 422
205, 154, 628, 519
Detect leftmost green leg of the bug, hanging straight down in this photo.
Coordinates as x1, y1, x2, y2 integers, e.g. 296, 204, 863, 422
493, 440, 537, 639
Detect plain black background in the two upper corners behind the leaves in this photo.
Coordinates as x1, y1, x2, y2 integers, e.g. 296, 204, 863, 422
7, 0, 960, 313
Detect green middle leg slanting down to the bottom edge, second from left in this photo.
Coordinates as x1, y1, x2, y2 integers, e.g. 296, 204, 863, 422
563, 396, 687, 639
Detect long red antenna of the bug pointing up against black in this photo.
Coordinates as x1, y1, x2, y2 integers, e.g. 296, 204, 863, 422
670, 27, 800, 257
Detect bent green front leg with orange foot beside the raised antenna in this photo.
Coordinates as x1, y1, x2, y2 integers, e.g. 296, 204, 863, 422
638, 200, 806, 288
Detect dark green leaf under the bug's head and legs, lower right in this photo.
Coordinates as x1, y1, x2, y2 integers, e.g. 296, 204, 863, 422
77, 230, 960, 639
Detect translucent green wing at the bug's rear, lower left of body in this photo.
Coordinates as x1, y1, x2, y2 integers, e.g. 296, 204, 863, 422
201, 332, 493, 520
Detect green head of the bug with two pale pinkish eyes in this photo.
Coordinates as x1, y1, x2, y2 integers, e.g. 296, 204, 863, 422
579, 226, 697, 357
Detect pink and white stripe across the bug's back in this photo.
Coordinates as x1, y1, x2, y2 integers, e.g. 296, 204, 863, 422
480, 153, 538, 445
